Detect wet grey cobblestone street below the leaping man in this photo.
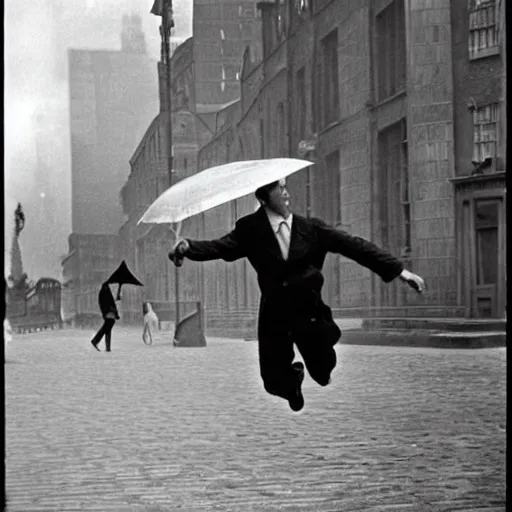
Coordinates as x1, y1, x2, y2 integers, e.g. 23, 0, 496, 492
5, 326, 506, 512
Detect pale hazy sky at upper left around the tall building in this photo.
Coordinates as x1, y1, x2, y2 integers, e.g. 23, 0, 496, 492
4, 0, 193, 280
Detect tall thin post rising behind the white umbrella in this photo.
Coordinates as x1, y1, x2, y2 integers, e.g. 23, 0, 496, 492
151, 0, 180, 327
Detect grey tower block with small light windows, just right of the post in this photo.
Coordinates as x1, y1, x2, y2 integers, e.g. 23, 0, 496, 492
193, 0, 261, 107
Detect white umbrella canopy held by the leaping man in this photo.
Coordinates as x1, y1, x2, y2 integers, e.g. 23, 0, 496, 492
138, 158, 313, 224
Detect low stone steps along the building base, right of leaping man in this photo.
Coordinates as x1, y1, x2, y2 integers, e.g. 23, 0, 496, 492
336, 317, 507, 348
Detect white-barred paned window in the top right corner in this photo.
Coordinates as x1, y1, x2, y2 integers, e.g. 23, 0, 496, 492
469, 0, 499, 59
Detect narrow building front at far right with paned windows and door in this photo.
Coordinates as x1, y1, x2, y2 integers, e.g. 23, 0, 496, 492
451, 0, 507, 317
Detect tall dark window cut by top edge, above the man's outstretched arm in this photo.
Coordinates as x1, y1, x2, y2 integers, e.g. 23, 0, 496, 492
376, 0, 407, 101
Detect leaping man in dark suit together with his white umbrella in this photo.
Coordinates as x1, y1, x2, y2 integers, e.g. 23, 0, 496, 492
141, 159, 425, 411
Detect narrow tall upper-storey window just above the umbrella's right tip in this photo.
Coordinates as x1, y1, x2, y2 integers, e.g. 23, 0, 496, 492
322, 29, 340, 125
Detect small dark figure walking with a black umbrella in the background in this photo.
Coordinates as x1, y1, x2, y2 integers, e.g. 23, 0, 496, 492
91, 260, 142, 352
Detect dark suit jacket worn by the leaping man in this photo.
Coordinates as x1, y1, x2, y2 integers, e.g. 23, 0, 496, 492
185, 208, 403, 343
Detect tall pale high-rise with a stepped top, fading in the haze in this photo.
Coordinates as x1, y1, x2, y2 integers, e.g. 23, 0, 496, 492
69, 16, 158, 234
